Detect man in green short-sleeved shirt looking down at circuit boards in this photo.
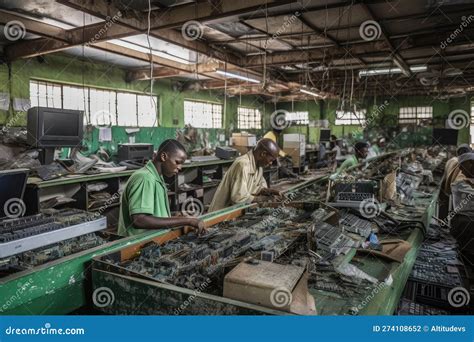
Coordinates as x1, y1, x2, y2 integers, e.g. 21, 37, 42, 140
118, 139, 204, 236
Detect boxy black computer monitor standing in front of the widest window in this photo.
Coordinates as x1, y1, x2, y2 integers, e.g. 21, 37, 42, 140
27, 107, 84, 164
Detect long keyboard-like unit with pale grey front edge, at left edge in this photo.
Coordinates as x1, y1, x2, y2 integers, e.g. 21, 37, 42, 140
0, 209, 107, 258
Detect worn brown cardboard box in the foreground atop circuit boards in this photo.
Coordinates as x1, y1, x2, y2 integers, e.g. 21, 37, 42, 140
224, 260, 316, 315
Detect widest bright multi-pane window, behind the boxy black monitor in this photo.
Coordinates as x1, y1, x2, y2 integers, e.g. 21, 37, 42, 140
30, 80, 158, 127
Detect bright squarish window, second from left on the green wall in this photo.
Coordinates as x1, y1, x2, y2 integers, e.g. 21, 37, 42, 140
184, 100, 222, 128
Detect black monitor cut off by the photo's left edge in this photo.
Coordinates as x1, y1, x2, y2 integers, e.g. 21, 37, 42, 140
0, 169, 29, 218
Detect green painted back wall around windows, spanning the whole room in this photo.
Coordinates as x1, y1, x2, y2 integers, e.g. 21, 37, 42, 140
0, 54, 471, 152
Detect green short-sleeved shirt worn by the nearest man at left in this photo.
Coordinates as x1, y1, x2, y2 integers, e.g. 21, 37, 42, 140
118, 161, 170, 236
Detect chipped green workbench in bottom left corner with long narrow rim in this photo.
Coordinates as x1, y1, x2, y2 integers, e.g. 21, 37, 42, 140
0, 205, 246, 315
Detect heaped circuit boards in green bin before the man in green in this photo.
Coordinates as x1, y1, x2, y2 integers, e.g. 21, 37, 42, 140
110, 207, 312, 288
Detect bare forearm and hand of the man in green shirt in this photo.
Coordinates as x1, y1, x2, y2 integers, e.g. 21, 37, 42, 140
132, 214, 205, 235
